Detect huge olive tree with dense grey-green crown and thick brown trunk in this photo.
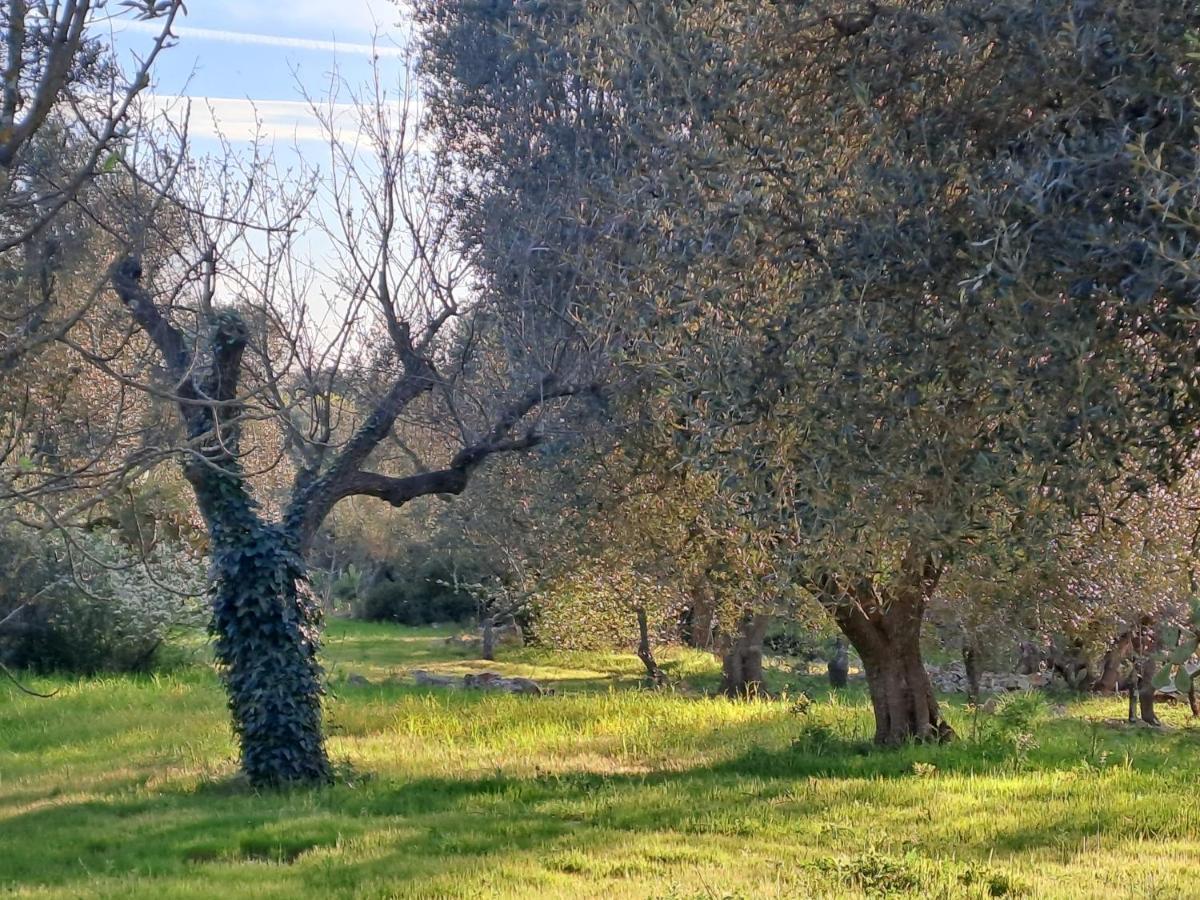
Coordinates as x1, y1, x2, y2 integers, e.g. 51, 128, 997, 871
451, 0, 1200, 744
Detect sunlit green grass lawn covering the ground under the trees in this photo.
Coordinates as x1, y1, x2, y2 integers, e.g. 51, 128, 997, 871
0, 622, 1200, 899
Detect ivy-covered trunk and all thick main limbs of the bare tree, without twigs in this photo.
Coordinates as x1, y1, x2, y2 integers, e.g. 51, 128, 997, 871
112, 217, 580, 787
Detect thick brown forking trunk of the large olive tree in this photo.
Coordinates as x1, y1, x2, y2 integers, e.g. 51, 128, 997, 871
820, 551, 954, 746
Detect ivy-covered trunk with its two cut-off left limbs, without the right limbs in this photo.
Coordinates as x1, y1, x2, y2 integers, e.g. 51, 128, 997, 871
113, 267, 330, 787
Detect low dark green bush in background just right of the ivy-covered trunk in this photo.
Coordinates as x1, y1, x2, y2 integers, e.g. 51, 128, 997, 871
354, 557, 476, 625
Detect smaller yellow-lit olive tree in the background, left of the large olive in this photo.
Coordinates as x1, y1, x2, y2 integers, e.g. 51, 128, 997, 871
443, 434, 792, 698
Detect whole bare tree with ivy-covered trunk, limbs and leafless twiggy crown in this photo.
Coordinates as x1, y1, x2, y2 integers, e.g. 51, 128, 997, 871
105, 60, 596, 785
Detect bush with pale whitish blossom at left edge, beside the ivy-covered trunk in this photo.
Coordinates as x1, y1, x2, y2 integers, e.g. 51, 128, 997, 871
0, 529, 206, 673
